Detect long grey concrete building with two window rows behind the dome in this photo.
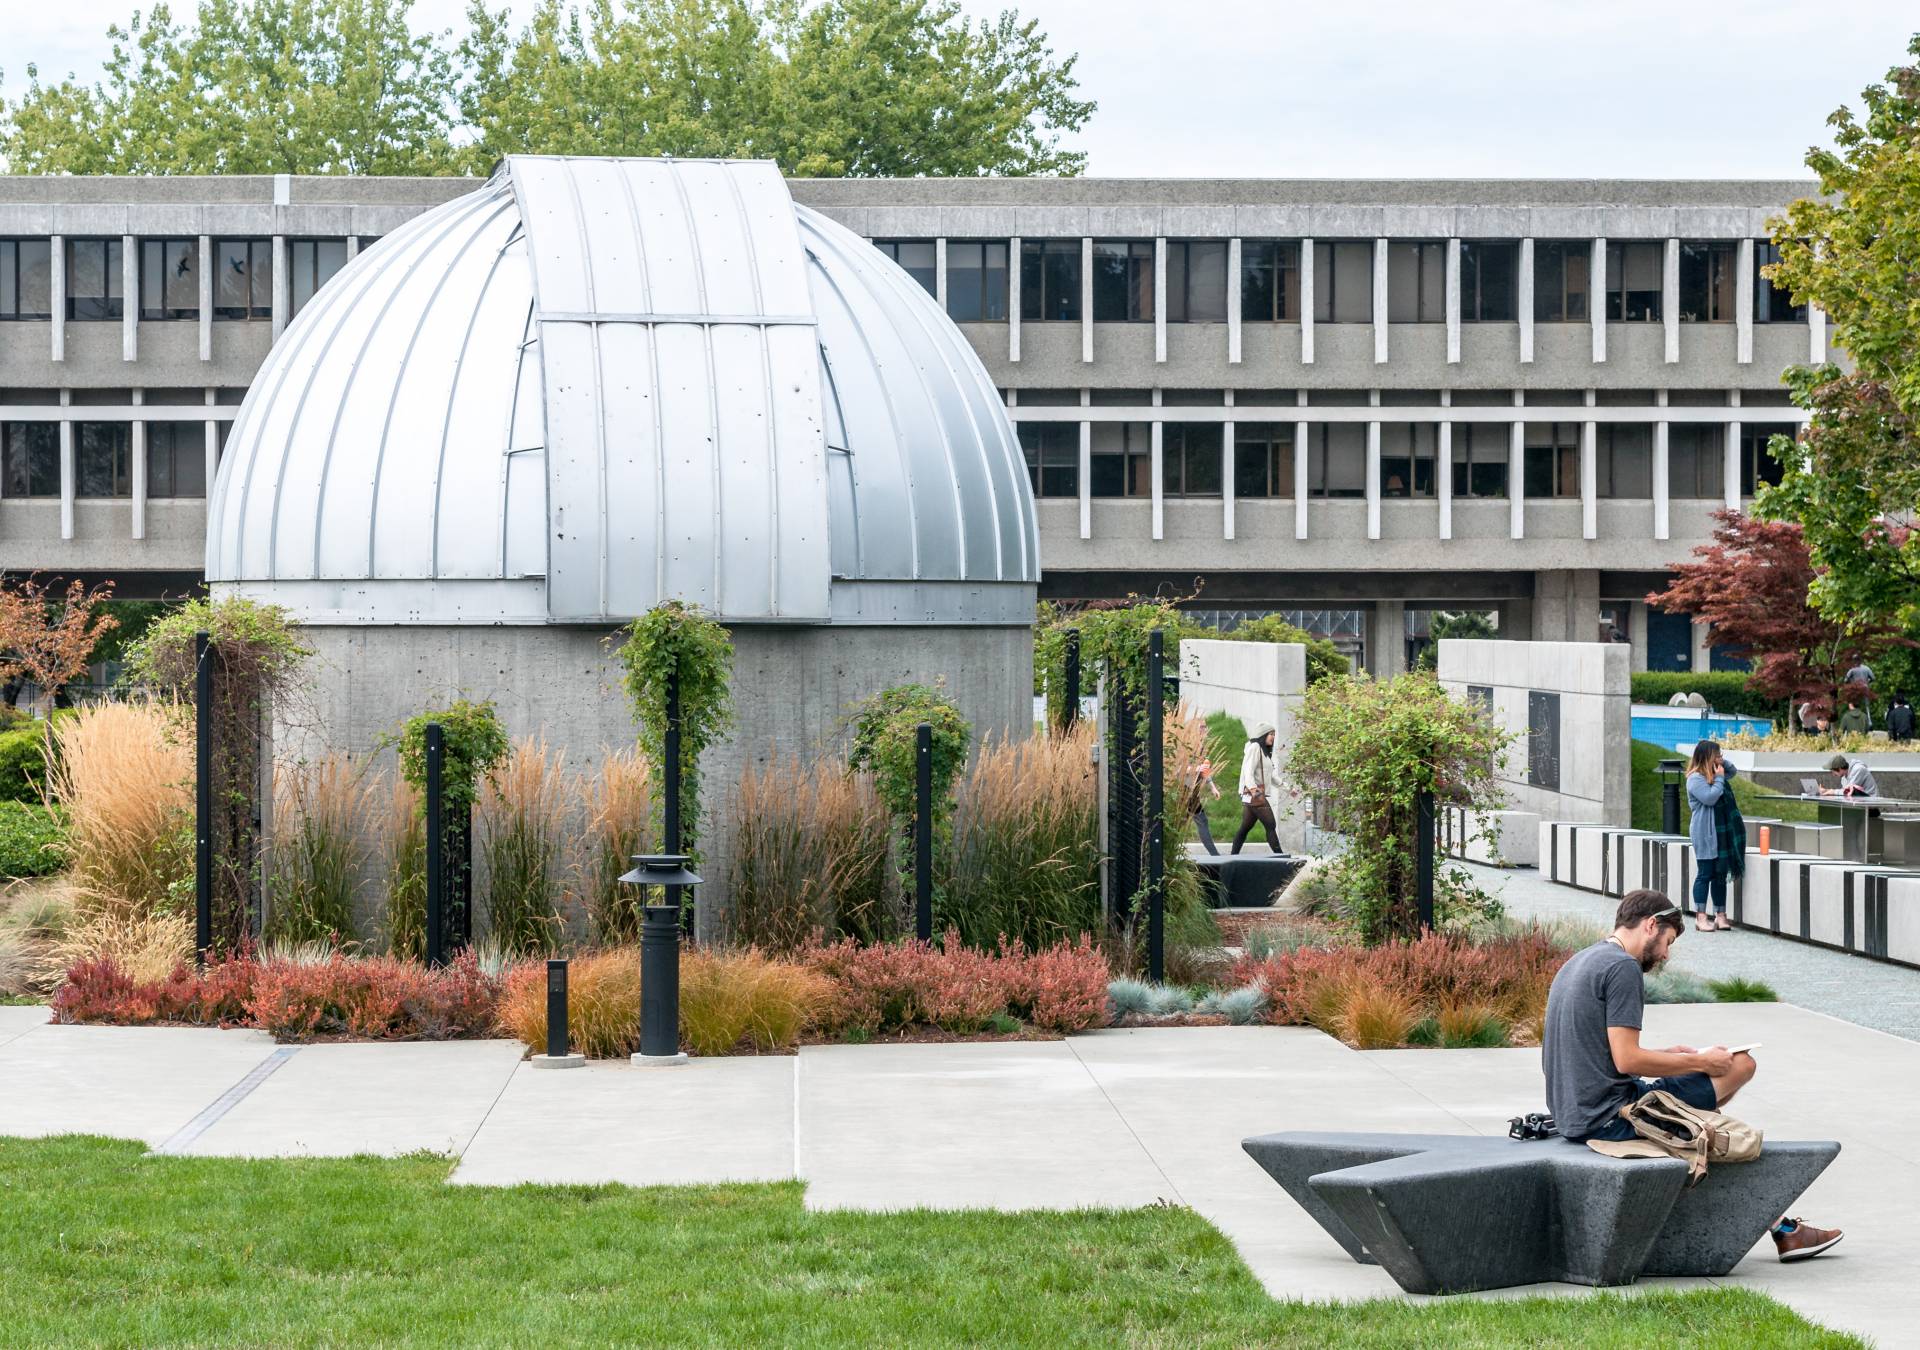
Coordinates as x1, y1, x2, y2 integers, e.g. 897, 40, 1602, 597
0, 177, 1826, 670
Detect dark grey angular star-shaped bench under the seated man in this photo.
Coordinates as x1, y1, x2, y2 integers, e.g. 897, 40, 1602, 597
1240, 1133, 1839, 1294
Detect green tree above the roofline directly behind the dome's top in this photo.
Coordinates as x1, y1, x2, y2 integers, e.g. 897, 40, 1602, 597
461, 0, 1094, 177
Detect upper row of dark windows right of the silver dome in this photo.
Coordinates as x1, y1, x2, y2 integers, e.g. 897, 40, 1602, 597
876, 238, 1807, 323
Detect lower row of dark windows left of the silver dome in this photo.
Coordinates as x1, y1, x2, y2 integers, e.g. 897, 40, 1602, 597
0, 422, 214, 497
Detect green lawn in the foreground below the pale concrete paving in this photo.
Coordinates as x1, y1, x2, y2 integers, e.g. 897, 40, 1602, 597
0, 1137, 1860, 1350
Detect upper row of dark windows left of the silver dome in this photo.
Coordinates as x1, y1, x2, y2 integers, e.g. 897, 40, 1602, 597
0, 238, 372, 323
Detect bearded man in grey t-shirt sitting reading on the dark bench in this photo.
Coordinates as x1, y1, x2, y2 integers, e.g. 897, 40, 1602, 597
1540, 891, 1841, 1262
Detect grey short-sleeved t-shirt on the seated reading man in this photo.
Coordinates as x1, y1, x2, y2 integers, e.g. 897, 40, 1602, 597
1540, 941, 1645, 1139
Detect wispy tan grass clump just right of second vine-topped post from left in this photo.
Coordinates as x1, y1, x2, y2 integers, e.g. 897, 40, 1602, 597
480, 735, 568, 956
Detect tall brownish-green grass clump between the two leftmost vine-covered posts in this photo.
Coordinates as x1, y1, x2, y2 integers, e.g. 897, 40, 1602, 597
265, 755, 371, 943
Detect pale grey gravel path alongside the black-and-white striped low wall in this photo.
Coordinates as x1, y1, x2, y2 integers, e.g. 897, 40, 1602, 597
1461, 862, 1920, 1041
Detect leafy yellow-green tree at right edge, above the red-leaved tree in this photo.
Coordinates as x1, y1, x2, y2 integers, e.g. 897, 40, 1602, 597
1757, 36, 1920, 630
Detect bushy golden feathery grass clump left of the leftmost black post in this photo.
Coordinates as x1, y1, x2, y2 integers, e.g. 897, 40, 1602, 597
48, 703, 194, 918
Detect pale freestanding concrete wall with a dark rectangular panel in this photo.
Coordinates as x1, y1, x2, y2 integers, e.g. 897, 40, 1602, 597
1438, 638, 1632, 826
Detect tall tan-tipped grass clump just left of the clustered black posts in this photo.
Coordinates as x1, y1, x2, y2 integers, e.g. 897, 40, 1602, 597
937, 722, 1100, 947
